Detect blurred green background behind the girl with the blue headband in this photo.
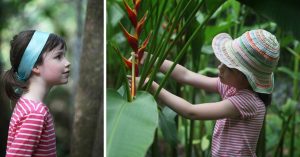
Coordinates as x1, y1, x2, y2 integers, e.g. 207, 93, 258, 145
0, 0, 81, 157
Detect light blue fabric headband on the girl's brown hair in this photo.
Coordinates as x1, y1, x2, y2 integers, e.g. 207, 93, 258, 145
17, 31, 50, 81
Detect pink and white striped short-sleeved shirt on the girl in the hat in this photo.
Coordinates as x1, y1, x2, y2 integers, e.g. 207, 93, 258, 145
212, 80, 266, 157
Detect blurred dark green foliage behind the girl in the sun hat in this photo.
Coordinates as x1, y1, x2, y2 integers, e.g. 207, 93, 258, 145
106, 0, 300, 156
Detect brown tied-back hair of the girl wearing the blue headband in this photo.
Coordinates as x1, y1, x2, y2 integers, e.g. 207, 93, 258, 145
3, 30, 67, 101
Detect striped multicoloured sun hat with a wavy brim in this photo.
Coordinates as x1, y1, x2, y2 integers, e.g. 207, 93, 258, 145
212, 29, 279, 94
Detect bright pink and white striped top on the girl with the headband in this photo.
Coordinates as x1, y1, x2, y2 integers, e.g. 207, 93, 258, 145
6, 97, 56, 157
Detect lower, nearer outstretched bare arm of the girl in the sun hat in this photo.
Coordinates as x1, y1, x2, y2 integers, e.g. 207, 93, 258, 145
151, 82, 240, 120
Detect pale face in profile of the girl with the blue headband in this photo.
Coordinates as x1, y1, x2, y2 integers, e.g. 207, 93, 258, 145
39, 45, 70, 86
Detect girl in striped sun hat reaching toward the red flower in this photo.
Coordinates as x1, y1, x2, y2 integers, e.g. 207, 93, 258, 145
137, 29, 279, 157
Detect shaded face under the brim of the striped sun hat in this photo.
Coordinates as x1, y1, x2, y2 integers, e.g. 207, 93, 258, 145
218, 63, 249, 89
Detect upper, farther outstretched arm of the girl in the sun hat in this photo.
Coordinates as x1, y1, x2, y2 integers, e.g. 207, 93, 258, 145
160, 60, 218, 92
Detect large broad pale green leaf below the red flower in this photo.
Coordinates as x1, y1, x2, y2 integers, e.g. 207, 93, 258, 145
107, 89, 158, 157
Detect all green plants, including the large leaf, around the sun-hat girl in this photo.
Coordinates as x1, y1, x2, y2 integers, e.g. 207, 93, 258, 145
106, 0, 300, 157
